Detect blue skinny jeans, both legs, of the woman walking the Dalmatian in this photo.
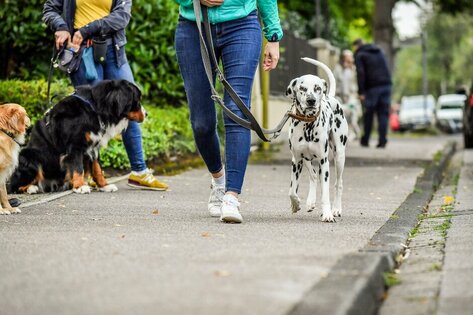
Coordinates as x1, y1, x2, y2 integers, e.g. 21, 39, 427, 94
175, 11, 262, 194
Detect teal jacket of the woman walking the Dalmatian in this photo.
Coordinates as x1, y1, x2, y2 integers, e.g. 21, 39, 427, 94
174, 0, 283, 41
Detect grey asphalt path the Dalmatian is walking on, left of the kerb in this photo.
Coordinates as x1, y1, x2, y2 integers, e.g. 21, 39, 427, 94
0, 137, 457, 315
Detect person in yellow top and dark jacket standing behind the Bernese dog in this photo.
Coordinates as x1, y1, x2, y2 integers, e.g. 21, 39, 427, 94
43, 0, 168, 190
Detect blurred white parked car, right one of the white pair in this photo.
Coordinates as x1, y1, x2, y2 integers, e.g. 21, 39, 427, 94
435, 94, 466, 133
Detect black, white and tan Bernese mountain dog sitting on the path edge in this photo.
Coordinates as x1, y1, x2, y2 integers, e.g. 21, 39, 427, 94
9, 80, 146, 194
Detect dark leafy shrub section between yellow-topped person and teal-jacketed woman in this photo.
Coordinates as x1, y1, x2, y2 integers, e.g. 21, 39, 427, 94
126, 0, 185, 106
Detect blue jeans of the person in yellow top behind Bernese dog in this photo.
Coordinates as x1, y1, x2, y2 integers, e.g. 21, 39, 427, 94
71, 45, 146, 172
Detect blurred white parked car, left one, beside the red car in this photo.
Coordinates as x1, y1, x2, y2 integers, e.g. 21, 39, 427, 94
399, 95, 435, 131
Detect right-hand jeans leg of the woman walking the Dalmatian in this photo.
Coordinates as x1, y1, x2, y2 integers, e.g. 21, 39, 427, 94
215, 14, 262, 195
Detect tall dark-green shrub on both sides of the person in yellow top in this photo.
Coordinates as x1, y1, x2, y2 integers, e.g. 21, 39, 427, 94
0, 0, 185, 106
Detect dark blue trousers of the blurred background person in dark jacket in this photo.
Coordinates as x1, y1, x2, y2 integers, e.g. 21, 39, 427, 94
361, 85, 391, 145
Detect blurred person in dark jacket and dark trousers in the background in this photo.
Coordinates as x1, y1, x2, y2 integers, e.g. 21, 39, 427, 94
353, 39, 392, 148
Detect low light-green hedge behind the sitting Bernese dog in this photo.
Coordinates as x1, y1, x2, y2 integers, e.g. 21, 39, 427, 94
0, 80, 196, 169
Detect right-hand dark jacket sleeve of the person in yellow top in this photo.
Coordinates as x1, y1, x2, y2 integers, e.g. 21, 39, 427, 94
79, 0, 132, 39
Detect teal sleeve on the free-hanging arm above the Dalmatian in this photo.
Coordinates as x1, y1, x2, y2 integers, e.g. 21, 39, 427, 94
256, 0, 283, 42
